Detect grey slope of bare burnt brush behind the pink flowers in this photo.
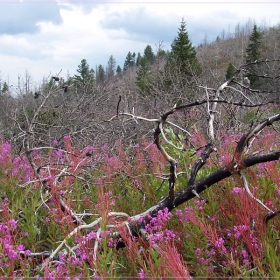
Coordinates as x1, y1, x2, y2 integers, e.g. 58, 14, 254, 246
0, 20, 280, 150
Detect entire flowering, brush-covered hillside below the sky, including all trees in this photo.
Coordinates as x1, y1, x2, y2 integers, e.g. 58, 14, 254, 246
0, 19, 280, 279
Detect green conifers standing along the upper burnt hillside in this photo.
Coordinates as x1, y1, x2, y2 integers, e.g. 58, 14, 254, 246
71, 19, 263, 95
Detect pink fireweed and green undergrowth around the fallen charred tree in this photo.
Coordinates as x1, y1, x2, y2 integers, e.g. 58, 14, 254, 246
0, 128, 280, 279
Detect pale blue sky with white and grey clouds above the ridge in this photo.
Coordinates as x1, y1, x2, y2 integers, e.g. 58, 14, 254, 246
0, 0, 280, 88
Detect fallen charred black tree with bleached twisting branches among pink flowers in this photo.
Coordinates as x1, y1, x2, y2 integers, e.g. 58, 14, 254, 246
37, 59, 280, 261
